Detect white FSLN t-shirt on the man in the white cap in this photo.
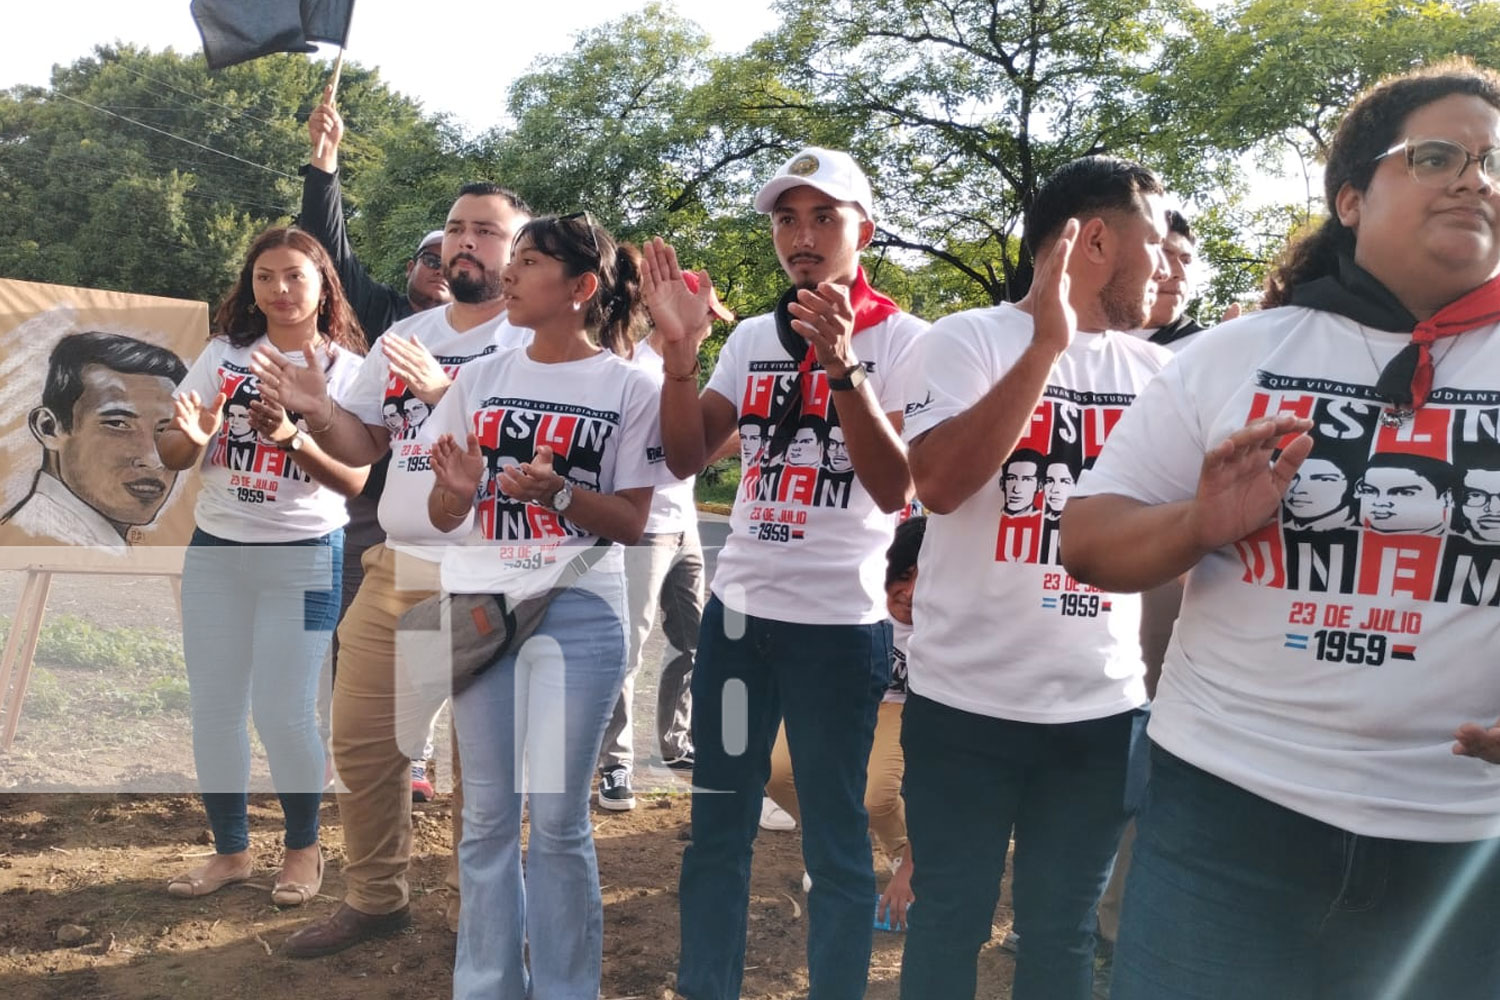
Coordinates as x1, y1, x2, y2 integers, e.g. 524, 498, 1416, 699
708, 312, 927, 625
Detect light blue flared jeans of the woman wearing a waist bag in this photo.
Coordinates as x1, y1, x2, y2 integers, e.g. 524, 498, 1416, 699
453, 588, 626, 1000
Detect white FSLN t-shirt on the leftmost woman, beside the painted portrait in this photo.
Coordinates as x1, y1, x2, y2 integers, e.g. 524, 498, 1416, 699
176, 336, 365, 543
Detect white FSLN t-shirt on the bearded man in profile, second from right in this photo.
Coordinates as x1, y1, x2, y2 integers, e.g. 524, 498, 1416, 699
906, 304, 1170, 723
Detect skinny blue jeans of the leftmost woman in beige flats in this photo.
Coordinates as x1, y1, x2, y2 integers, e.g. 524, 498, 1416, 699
183, 529, 344, 855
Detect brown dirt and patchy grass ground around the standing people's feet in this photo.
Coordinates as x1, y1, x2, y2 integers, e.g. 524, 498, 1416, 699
0, 573, 1013, 1000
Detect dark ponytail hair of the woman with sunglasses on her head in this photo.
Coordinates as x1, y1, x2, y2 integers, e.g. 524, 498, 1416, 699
516, 213, 647, 358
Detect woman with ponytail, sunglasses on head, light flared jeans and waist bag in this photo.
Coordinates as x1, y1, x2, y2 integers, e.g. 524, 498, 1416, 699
423, 213, 666, 1000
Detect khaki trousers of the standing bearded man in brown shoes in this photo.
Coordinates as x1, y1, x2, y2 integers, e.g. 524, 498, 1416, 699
333, 544, 464, 915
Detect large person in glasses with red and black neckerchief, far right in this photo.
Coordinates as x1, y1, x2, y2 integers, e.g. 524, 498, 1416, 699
1064, 61, 1500, 1000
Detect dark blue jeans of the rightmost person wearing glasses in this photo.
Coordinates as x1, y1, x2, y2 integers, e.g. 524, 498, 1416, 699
1110, 747, 1500, 1000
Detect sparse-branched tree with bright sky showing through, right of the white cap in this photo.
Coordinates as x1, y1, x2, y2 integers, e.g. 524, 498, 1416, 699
777, 0, 1179, 301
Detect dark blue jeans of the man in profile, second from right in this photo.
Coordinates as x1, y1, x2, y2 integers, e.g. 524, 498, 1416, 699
902, 692, 1145, 1000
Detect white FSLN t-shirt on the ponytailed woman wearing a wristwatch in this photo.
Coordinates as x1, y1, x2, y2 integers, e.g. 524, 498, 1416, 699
423, 349, 672, 594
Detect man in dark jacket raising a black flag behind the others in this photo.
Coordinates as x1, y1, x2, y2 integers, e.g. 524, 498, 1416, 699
297, 88, 458, 803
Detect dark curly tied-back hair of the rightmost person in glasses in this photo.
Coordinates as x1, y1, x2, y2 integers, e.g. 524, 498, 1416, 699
1260, 58, 1500, 309
